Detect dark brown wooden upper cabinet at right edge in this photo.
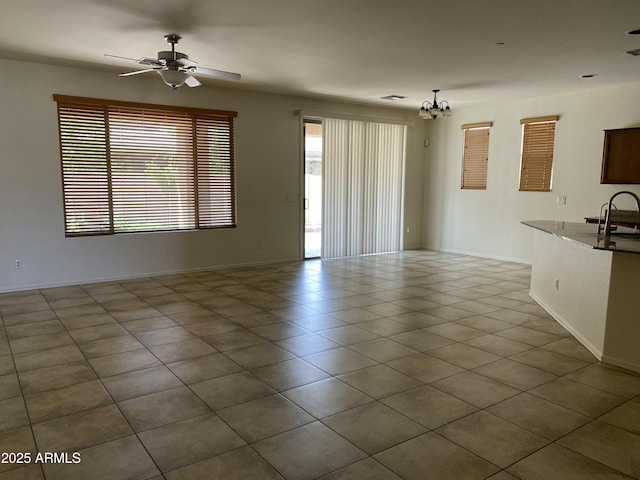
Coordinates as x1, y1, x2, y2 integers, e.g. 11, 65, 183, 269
600, 128, 640, 184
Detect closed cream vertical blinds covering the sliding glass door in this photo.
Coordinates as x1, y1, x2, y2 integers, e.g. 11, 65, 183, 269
321, 118, 406, 258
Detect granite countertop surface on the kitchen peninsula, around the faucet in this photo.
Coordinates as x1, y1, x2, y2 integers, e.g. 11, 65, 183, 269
522, 220, 640, 253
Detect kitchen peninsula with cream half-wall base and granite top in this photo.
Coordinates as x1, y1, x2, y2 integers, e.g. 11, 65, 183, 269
522, 220, 640, 372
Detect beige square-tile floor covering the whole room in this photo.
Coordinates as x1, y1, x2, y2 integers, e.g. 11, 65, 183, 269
0, 251, 640, 480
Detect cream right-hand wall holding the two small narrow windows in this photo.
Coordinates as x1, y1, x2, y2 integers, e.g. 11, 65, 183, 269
423, 84, 640, 262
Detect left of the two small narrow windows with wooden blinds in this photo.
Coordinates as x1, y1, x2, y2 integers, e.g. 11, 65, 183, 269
461, 122, 493, 190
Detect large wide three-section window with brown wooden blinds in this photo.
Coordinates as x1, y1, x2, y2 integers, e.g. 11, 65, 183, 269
54, 95, 237, 236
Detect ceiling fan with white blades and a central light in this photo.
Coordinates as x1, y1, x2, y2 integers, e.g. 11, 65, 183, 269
105, 33, 240, 90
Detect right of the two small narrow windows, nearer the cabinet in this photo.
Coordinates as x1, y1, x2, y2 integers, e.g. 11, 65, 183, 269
520, 116, 558, 192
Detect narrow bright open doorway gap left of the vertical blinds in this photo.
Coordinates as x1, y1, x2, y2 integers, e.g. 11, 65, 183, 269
304, 120, 322, 259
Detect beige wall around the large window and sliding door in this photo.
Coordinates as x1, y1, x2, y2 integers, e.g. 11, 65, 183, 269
0, 60, 428, 292
